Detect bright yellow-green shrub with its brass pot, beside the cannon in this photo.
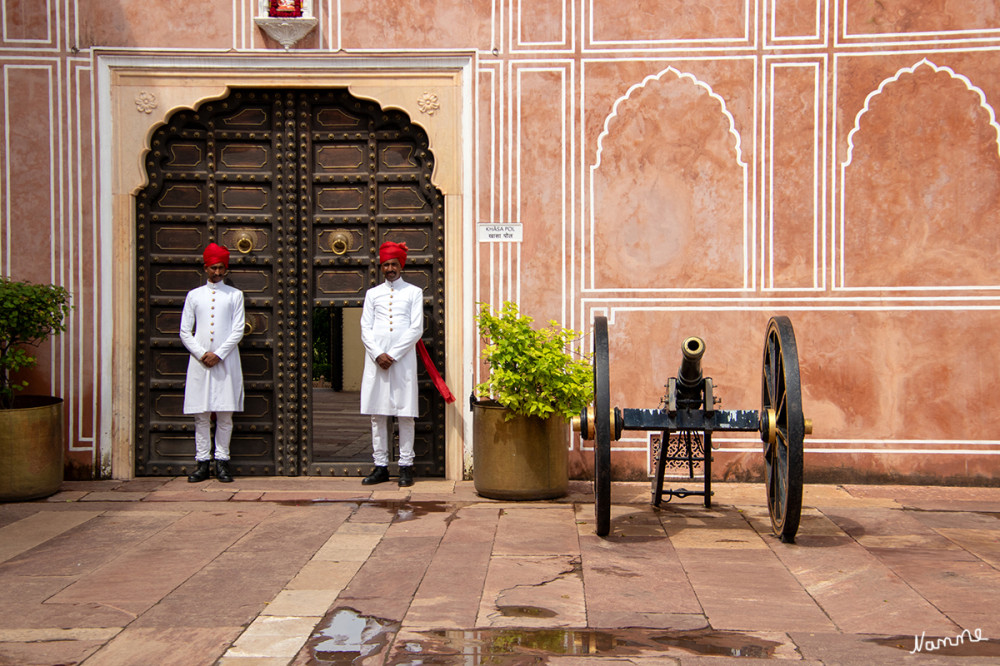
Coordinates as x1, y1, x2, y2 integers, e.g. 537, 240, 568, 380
472, 301, 594, 500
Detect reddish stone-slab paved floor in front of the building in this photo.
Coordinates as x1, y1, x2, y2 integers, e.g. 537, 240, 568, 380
0, 477, 1000, 666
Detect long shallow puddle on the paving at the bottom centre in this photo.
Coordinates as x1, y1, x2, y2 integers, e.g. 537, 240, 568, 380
386, 629, 782, 666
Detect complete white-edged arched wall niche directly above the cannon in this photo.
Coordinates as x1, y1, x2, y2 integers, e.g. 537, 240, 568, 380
588, 67, 752, 289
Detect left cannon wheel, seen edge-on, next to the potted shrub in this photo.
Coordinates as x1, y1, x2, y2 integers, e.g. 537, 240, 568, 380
594, 316, 611, 536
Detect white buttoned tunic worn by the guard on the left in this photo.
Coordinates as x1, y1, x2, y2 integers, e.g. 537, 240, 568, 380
181, 282, 244, 414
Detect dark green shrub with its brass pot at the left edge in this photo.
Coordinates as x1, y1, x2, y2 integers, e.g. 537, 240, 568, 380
0, 276, 70, 502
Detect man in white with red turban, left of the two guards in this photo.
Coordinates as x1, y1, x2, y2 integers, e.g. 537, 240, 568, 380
180, 243, 244, 483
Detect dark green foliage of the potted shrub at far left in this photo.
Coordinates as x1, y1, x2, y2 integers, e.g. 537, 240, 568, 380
0, 277, 71, 409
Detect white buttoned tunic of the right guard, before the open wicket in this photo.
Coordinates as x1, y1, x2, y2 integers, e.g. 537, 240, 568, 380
361, 278, 424, 417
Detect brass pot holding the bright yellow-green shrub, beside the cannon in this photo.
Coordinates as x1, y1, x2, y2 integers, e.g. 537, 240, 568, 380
472, 402, 569, 500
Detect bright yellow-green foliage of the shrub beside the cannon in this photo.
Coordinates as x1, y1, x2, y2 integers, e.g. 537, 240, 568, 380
476, 301, 594, 420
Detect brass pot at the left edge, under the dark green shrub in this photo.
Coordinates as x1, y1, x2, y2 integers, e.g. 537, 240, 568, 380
0, 395, 63, 502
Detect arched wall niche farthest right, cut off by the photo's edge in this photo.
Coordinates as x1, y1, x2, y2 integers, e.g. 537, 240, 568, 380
839, 59, 1000, 289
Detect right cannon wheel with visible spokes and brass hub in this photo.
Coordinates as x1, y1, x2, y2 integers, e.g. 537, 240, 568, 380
760, 317, 806, 543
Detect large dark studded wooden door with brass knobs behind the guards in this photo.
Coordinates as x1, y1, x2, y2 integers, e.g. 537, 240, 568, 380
136, 89, 444, 476
